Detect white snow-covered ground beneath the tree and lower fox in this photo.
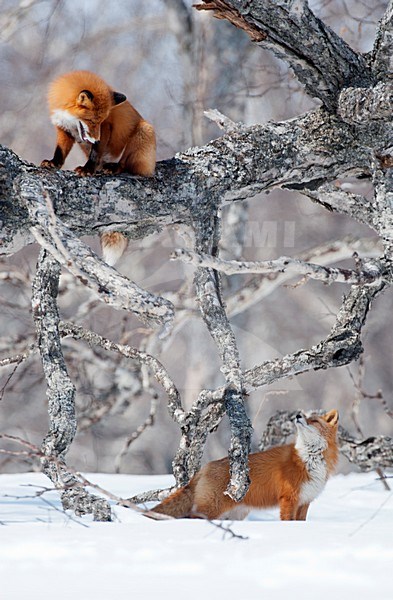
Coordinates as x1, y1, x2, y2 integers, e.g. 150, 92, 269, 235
0, 473, 393, 600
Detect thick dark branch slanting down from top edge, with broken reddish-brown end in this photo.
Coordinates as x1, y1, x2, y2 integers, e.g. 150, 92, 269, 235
196, 0, 372, 112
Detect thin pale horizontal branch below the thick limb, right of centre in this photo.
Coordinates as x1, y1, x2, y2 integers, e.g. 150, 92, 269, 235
171, 248, 382, 285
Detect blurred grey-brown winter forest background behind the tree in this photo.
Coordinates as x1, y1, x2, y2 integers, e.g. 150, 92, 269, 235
0, 0, 393, 473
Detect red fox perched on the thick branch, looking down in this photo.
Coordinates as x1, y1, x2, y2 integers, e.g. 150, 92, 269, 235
41, 71, 156, 265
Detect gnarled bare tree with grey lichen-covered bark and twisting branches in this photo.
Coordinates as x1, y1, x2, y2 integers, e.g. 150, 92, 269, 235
0, 0, 393, 519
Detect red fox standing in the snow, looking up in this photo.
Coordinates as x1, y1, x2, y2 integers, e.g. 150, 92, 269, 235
152, 410, 338, 521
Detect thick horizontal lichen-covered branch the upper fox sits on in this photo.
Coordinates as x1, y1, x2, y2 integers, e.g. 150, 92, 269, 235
0, 110, 391, 254
